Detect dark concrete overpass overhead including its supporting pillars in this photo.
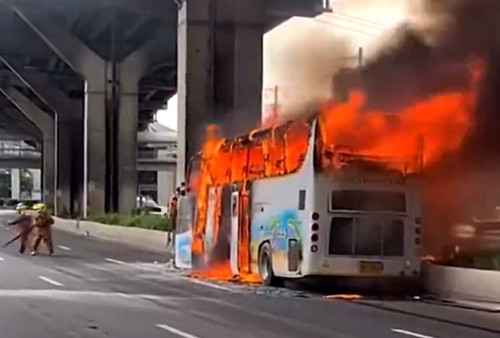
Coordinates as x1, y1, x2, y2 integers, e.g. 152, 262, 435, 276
0, 0, 323, 215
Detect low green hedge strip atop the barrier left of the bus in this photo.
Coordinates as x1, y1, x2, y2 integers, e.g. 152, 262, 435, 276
89, 214, 172, 231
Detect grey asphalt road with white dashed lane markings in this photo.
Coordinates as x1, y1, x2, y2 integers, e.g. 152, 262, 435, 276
0, 211, 500, 338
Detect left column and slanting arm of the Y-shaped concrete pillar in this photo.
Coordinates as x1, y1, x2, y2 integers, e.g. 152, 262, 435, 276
10, 2, 108, 217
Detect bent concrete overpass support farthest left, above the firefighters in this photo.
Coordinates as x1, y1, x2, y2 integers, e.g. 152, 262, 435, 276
0, 85, 57, 210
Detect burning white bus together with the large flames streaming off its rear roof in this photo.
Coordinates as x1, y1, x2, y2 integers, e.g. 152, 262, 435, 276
176, 48, 481, 284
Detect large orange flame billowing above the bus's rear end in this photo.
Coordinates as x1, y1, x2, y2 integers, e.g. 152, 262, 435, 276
319, 92, 473, 164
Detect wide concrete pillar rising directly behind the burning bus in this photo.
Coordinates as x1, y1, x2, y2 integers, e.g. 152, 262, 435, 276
177, 0, 265, 181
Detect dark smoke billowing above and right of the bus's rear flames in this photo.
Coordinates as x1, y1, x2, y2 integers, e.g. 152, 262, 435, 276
334, 0, 500, 252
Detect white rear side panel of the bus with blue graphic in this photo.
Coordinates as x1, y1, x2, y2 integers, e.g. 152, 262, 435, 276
250, 124, 316, 277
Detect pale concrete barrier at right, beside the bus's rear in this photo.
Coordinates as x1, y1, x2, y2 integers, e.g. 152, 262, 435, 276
424, 265, 500, 303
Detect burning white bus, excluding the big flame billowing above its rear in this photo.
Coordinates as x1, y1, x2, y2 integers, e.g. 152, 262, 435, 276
176, 109, 430, 285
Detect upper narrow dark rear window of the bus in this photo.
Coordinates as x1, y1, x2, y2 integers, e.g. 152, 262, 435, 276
330, 190, 406, 212
